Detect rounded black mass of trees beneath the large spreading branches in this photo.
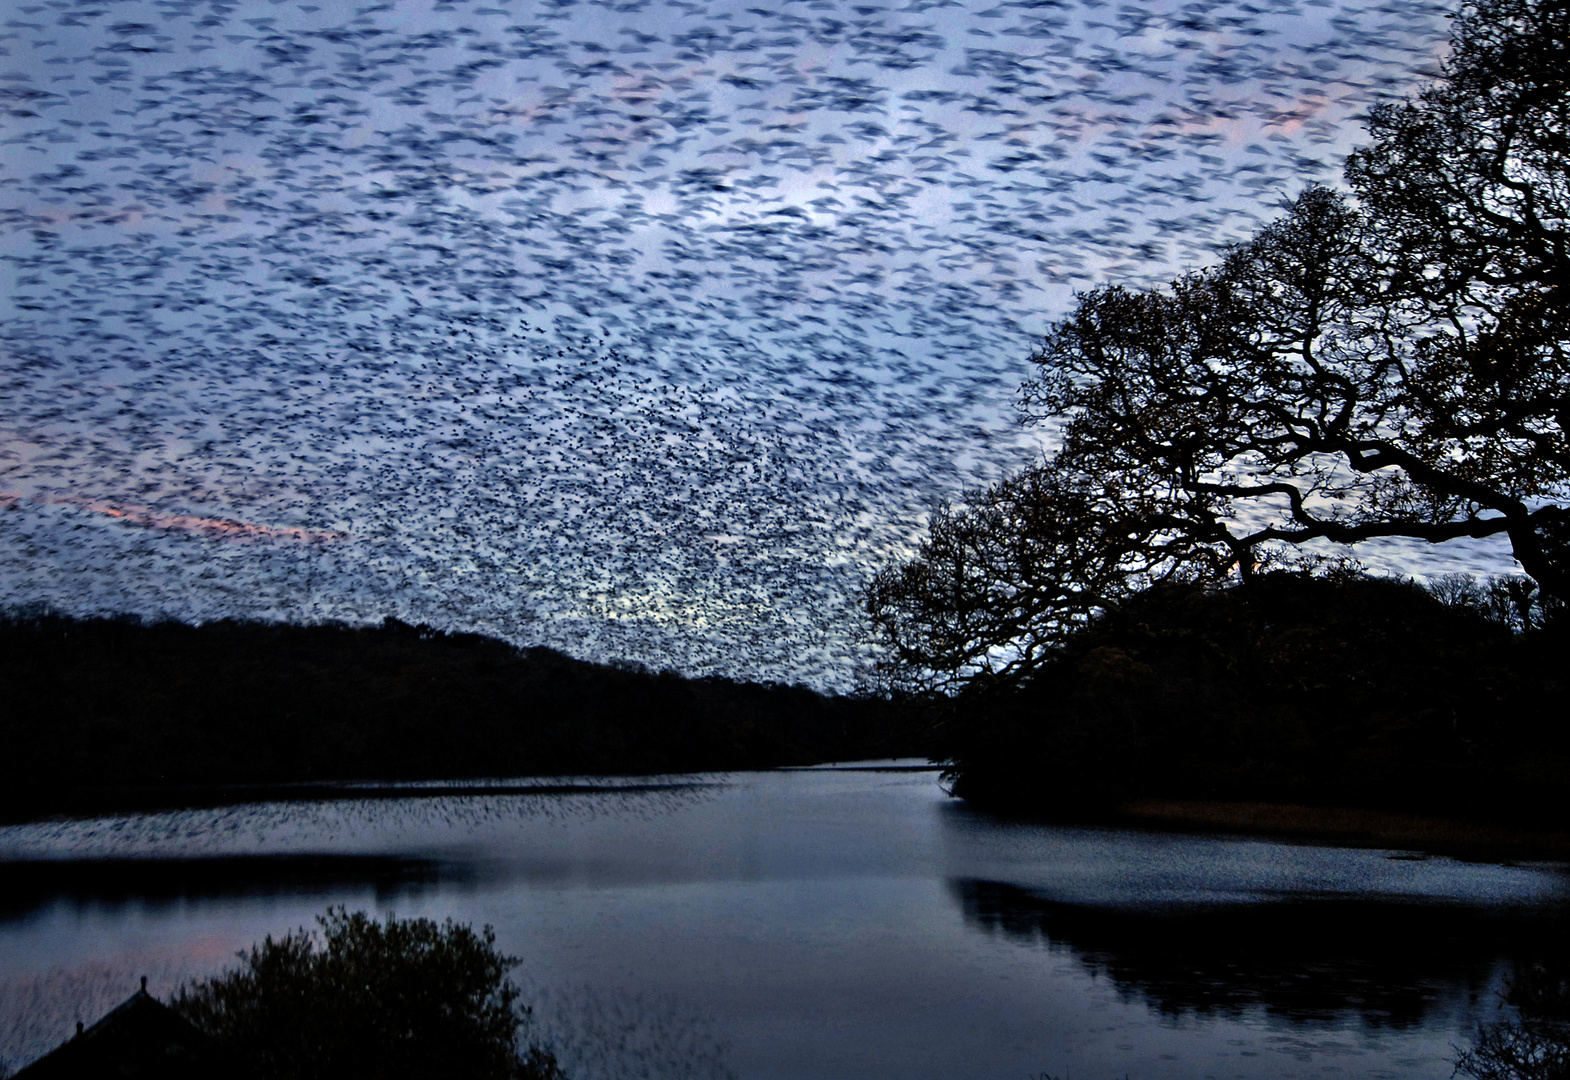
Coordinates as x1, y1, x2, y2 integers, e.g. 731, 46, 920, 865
937, 573, 1570, 829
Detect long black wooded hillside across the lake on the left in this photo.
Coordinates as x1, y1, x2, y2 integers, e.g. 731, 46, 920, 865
0, 612, 926, 818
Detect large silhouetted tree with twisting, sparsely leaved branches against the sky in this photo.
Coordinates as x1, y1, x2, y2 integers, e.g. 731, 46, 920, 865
865, 0, 1570, 688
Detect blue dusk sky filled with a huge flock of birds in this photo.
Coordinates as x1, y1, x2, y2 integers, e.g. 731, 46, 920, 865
0, 0, 1444, 681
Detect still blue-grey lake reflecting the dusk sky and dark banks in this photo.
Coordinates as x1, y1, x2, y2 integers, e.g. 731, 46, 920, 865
0, 763, 1570, 1080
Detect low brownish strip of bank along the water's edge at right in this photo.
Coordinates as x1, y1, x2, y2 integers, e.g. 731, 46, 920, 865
1116, 799, 1570, 860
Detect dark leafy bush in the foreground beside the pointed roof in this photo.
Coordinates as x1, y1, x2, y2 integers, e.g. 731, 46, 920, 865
173, 907, 564, 1080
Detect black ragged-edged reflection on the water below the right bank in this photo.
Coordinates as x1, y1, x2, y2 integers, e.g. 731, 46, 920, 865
950, 879, 1567, 1030
